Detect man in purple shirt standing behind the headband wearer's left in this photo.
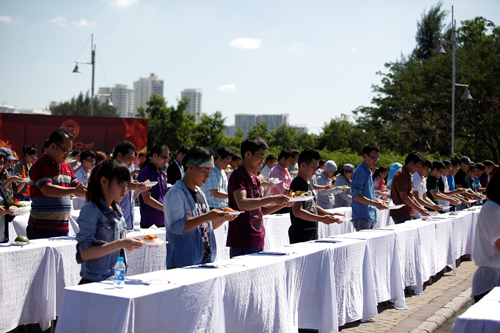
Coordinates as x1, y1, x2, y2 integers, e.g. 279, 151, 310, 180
137, 143, 170, 228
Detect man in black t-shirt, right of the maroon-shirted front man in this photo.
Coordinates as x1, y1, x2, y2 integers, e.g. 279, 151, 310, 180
288, 148, 343, 244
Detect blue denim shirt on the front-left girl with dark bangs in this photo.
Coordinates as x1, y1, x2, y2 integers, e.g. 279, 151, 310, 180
76, 199, 127, 282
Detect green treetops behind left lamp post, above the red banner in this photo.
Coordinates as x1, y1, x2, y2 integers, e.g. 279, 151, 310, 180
50, 92, 118, 117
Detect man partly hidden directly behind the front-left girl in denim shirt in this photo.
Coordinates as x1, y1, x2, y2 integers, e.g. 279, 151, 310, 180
113, 141, 147, 230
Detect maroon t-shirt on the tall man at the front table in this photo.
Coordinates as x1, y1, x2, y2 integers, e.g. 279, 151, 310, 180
227, 166, 266, 249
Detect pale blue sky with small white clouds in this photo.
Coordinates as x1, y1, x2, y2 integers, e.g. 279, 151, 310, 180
0, 0, 500, 133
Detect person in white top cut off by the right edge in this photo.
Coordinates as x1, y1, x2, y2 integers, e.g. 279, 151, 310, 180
472, 172, 500, 302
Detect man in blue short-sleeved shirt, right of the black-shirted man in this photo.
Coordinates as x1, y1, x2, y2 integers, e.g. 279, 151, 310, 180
351, 144, 388, 231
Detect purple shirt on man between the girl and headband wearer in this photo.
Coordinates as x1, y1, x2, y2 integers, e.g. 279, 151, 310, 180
137, 163, 168, 227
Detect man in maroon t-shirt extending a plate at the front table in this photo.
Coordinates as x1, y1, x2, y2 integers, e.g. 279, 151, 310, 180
227, 137, 290, 258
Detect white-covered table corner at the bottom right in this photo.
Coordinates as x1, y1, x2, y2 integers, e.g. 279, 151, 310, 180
451, 287, 500, 333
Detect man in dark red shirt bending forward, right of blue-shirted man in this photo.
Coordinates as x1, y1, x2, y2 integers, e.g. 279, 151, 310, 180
390, 151, 429, 224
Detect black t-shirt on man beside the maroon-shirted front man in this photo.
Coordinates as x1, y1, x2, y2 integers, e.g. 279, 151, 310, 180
288, 177, 318, 244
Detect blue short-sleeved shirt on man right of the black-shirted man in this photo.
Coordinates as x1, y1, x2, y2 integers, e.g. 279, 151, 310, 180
351, 162, 377, 223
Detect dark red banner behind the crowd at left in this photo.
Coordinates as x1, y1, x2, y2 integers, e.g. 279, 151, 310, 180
0, 113, 148, 157
